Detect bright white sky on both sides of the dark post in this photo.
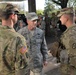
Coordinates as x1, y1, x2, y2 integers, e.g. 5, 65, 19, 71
2, 0, 45, 11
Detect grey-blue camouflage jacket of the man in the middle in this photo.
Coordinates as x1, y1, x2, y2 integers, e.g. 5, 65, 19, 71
18, 27, 48, 71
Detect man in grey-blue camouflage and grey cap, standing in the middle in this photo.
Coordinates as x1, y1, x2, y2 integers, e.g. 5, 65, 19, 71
18, 12, 48, 75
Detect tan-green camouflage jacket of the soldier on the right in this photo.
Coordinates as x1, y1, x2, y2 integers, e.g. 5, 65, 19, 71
61, 25, 76, 66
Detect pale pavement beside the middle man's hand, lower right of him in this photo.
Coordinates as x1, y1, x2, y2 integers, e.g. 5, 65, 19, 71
43, 53, 60, 75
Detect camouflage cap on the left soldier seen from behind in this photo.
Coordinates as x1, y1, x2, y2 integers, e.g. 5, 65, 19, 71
0, 3, 19, 18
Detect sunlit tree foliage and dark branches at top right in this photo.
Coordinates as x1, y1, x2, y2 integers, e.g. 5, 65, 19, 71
44, 0, 76, 14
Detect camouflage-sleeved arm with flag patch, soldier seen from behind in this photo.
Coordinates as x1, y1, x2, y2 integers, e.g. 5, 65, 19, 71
15, 37, 28, 74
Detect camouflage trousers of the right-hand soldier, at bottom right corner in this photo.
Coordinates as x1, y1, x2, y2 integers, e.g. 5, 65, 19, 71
60, 64, 76, 75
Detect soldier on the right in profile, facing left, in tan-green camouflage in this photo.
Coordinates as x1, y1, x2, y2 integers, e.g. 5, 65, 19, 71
58, 7, 76, 75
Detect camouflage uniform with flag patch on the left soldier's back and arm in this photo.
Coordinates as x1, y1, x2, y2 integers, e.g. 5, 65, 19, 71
0, 26, 28, 75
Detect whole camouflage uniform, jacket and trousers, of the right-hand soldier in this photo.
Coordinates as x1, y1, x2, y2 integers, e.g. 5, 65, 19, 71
61, 25, 76, 75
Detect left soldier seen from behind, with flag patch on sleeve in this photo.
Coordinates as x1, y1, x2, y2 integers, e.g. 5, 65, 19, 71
0, 4, 28, 75
